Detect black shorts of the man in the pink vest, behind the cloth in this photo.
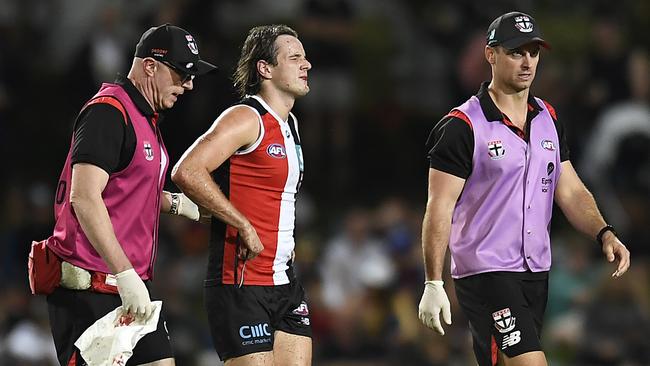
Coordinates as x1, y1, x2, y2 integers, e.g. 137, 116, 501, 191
47, 287, 174, 366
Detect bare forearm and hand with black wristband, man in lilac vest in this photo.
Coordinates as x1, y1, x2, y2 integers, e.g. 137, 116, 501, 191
555, 161, 630, 277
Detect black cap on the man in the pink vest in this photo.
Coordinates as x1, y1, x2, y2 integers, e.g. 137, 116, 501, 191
135, 24, 217, 75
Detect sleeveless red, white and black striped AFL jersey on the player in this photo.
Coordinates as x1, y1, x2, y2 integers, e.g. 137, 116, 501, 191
206, 96, 303, 286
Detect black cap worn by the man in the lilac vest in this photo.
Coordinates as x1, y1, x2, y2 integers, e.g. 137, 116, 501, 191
487, 11, 550, 50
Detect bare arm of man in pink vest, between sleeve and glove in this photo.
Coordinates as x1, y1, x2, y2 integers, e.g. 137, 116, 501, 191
70, 163, 133, 273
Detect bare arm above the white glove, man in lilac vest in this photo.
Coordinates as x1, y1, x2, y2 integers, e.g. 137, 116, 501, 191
422, 169, 465, 281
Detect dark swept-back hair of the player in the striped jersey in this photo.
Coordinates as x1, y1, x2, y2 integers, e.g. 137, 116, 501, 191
233, 24, 298, 98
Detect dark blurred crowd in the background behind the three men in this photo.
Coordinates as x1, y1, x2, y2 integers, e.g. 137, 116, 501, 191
0, 0, 650, 366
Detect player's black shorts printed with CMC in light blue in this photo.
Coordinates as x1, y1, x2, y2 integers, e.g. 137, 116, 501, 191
205, 280, 311, 361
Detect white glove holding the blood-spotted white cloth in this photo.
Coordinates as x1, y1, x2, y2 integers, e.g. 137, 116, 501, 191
115, 268, 154, 319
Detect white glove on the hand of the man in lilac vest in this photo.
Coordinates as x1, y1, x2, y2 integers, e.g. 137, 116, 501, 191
418, 281, 451, 335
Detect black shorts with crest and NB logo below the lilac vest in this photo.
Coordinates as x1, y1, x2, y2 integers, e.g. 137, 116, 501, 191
454, 272, 548, 366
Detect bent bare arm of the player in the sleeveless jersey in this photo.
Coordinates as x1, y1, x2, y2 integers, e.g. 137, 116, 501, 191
172, 106, 262, 253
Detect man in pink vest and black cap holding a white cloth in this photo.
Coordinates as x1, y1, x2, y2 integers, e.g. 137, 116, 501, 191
46, 24, 216, 365
